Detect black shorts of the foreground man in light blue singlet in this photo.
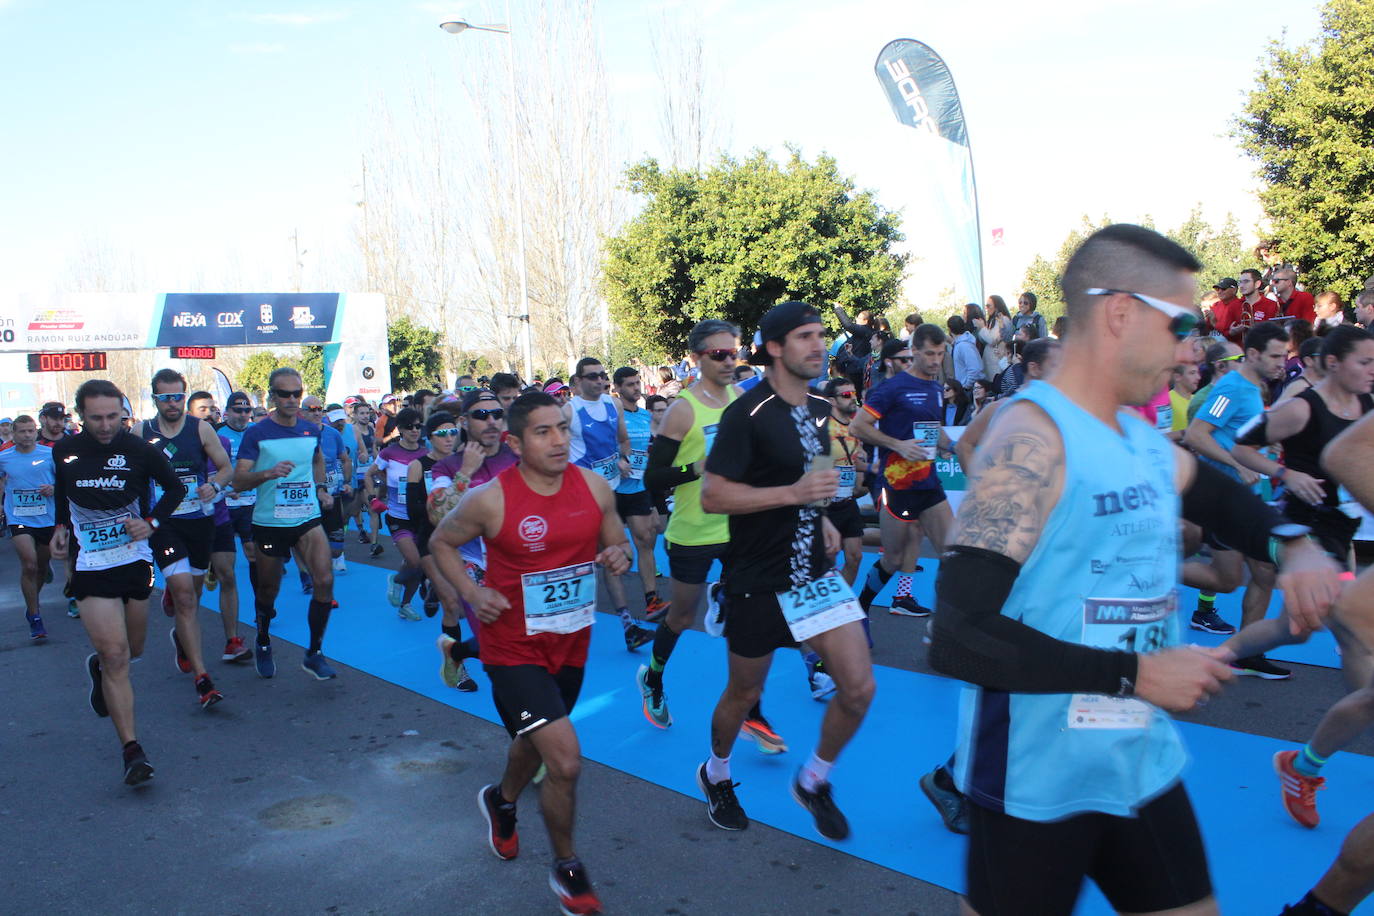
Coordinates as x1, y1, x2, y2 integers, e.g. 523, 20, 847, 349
967, 783, 1212, 916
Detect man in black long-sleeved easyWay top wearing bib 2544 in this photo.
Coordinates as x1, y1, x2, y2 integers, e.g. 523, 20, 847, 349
52, 379, 185, 786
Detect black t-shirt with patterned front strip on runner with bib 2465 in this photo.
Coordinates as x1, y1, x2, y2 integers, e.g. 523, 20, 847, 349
706, 379, 830, 595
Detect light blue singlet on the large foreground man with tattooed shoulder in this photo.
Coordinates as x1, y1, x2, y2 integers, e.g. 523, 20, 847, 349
955, 382, 1186, 821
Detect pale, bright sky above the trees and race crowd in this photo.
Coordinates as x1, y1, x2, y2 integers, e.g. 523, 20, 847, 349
0, 0, 1319, 308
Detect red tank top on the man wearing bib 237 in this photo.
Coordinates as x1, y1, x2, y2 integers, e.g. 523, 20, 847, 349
481, 466, 602, 673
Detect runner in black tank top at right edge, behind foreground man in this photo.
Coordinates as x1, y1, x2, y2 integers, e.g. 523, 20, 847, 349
1226, 325, 1374, 827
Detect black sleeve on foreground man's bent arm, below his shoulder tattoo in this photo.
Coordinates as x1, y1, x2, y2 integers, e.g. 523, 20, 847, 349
929, 545, 1139, 696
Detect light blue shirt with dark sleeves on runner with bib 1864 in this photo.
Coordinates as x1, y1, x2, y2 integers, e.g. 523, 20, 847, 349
239, 413, 320, 527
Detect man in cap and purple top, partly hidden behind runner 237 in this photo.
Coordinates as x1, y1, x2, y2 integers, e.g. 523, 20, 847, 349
429, 387, 518, 692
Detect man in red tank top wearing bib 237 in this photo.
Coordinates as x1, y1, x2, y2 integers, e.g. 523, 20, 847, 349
431, 393, 629, 915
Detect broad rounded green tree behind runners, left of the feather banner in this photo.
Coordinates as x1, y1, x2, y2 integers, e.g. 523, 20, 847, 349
605, 148, 907, 358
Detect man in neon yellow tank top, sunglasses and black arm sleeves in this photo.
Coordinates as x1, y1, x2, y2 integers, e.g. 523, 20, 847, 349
635, 319, 787, 754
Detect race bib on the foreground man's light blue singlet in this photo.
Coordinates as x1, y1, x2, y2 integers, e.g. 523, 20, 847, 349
1069, 592, 1178, 728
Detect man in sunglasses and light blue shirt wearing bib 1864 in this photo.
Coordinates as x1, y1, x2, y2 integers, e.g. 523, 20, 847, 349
234, 367, 337, 681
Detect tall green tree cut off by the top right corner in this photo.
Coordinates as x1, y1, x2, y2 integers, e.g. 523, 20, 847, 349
1235, 0, 1374, 294
